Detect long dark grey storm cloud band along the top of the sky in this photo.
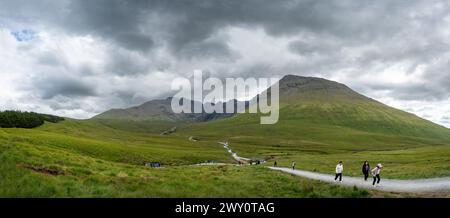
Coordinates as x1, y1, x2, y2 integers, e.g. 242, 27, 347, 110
0, 0, 413, 56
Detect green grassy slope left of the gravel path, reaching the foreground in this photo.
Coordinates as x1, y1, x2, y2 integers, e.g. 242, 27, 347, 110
0, 120, 391, 197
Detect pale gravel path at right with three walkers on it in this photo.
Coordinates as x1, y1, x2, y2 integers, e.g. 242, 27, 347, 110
269, 167, 450, 193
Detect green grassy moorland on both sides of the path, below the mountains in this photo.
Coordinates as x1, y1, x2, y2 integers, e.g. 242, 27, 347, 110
0, 113, 449, 197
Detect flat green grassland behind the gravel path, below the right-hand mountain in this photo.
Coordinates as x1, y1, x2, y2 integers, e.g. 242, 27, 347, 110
182, 123, 450, 178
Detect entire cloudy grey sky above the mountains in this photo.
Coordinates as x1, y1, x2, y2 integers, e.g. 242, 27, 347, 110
0, 0, 450, 127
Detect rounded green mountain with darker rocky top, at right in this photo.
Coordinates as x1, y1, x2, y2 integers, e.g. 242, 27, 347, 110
243, 75, 450, 140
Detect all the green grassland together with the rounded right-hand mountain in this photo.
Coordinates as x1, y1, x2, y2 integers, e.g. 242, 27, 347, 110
0, 76, 450, 197
